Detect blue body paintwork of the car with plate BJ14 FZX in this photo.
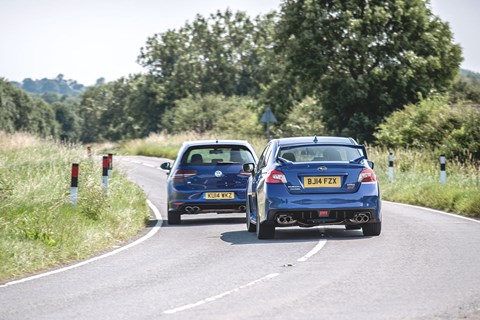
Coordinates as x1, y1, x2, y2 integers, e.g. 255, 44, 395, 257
247, 137, 382, 238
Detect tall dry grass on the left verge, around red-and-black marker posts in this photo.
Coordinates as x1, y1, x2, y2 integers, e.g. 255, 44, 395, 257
0, 133, 148, 281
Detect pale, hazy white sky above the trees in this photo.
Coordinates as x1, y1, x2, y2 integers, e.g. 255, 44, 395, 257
0, 0, 480, 86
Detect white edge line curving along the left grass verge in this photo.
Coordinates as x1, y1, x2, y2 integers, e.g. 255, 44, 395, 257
0, 200, 162, 288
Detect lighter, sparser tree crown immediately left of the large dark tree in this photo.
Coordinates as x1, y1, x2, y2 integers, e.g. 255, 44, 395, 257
139, 9, 275, 102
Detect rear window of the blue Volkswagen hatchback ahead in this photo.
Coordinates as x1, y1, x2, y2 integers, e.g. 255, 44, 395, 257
181, 145, 255, 166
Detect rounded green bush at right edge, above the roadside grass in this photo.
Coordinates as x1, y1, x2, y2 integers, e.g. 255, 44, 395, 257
375, 95, 480, 160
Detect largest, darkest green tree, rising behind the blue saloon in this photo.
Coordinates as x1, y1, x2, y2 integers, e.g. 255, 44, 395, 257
277, 0, 462, 141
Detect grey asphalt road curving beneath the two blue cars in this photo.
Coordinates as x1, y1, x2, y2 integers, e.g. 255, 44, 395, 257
0, 157, 480, 320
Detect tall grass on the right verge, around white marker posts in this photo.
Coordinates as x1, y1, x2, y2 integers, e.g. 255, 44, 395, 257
368, 147, 480, 217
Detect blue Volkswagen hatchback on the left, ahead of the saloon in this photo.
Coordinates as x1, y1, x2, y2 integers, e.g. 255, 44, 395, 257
160, 140, 257, 224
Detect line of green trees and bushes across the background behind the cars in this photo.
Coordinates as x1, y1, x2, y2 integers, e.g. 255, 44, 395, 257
0, 0, 480, 158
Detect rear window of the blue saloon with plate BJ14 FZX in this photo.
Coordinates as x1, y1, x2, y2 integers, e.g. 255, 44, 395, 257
278, 145, 363, 162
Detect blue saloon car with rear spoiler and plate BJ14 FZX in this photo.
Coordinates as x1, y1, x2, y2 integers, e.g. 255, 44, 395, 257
244, 137, 382, 239
